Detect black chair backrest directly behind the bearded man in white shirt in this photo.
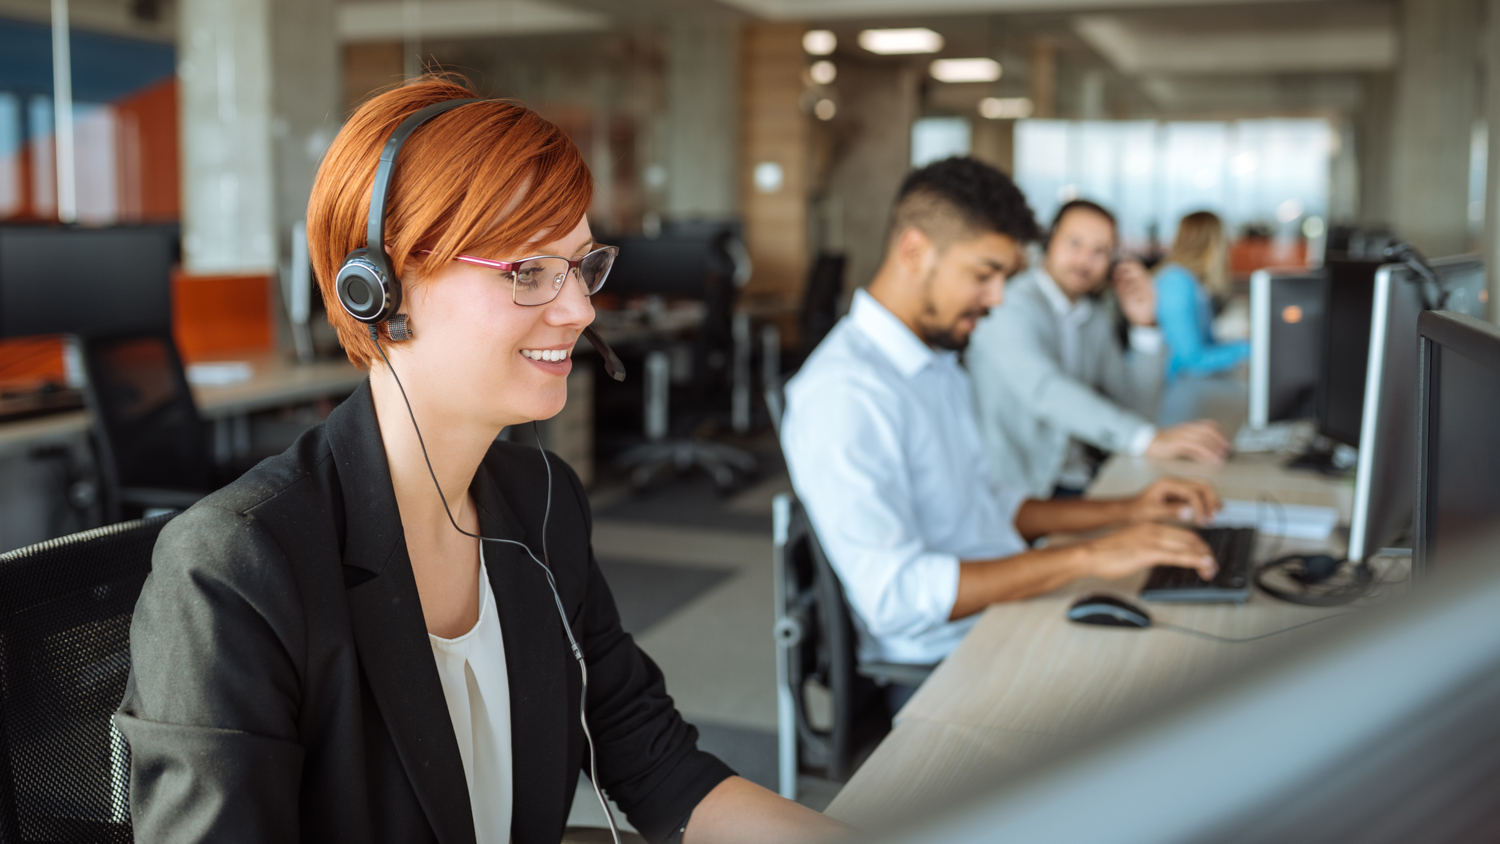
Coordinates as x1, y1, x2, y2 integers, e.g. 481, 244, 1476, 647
777, 495, 891, 780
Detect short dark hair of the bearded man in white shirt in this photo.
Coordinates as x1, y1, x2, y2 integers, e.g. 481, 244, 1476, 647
891, 157, 1041, 246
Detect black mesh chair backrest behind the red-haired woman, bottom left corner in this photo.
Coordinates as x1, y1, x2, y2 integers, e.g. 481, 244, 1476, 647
0, 516, 171, 844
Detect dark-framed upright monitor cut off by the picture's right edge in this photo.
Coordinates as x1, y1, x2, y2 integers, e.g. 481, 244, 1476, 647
1412, 310, 1500, 574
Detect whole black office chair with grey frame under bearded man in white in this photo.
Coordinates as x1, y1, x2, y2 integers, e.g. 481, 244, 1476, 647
773, 493, 933, 799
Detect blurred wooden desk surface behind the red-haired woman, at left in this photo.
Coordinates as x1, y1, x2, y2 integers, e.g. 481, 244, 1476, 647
0, 354, 366, 457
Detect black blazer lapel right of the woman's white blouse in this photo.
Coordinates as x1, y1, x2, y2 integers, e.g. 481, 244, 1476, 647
473, 462, 582, 841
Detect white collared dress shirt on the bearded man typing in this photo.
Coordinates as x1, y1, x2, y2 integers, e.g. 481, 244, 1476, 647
782, 291, 1026, 663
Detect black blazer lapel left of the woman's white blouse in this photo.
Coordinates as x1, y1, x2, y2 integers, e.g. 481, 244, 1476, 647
327, 381, 474, 844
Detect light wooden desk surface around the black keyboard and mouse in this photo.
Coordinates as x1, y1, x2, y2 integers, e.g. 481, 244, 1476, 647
828, 422, 1374, 829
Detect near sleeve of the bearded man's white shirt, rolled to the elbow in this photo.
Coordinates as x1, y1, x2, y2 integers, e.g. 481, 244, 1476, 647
782, 376, 960, 637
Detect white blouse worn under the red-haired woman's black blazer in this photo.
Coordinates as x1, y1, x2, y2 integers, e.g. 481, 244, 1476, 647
428, 543, 515, 844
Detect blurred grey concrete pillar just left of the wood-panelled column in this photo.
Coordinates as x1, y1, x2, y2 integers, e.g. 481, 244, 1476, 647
662, 15, 740, 219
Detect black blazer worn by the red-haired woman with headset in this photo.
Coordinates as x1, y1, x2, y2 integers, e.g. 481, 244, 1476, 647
116, 382, 734, 844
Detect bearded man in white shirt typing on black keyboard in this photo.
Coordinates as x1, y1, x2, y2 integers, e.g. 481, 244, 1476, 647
782, 159, 1218, 695
